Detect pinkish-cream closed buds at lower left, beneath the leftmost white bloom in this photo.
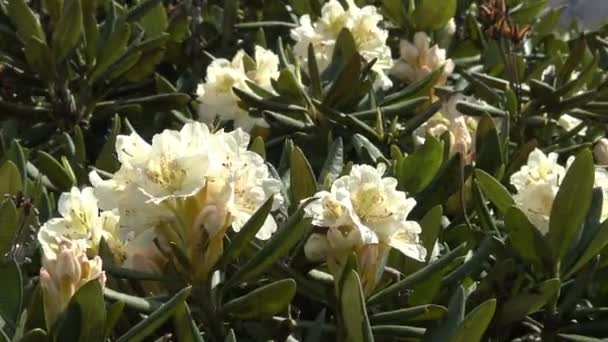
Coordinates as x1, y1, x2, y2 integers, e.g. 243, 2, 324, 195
40, 239, 106, 325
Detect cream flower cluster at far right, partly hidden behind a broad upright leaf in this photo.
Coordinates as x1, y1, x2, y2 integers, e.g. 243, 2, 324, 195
511, 149, 608, 234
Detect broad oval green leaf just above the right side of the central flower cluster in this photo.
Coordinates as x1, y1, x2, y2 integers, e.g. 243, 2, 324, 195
396, 135, 443, 195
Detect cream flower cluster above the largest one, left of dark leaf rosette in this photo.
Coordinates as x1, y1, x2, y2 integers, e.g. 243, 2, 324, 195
197, 46, 279, 131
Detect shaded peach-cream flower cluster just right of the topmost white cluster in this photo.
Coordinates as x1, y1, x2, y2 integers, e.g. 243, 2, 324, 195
391, 32, 454, 86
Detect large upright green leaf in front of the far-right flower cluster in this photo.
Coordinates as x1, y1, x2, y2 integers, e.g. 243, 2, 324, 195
547, 150, 595, 263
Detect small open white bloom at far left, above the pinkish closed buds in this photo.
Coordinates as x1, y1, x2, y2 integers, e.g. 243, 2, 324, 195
38, 188, 119, 258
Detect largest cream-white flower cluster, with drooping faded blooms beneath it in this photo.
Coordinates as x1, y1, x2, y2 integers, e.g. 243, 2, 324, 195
90, 122, 283, 277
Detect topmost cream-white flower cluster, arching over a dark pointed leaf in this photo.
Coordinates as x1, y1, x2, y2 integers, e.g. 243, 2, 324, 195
291, 0, 393, 89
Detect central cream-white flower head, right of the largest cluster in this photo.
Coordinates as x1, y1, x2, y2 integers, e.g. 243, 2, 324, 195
305, 164, 426, 260
